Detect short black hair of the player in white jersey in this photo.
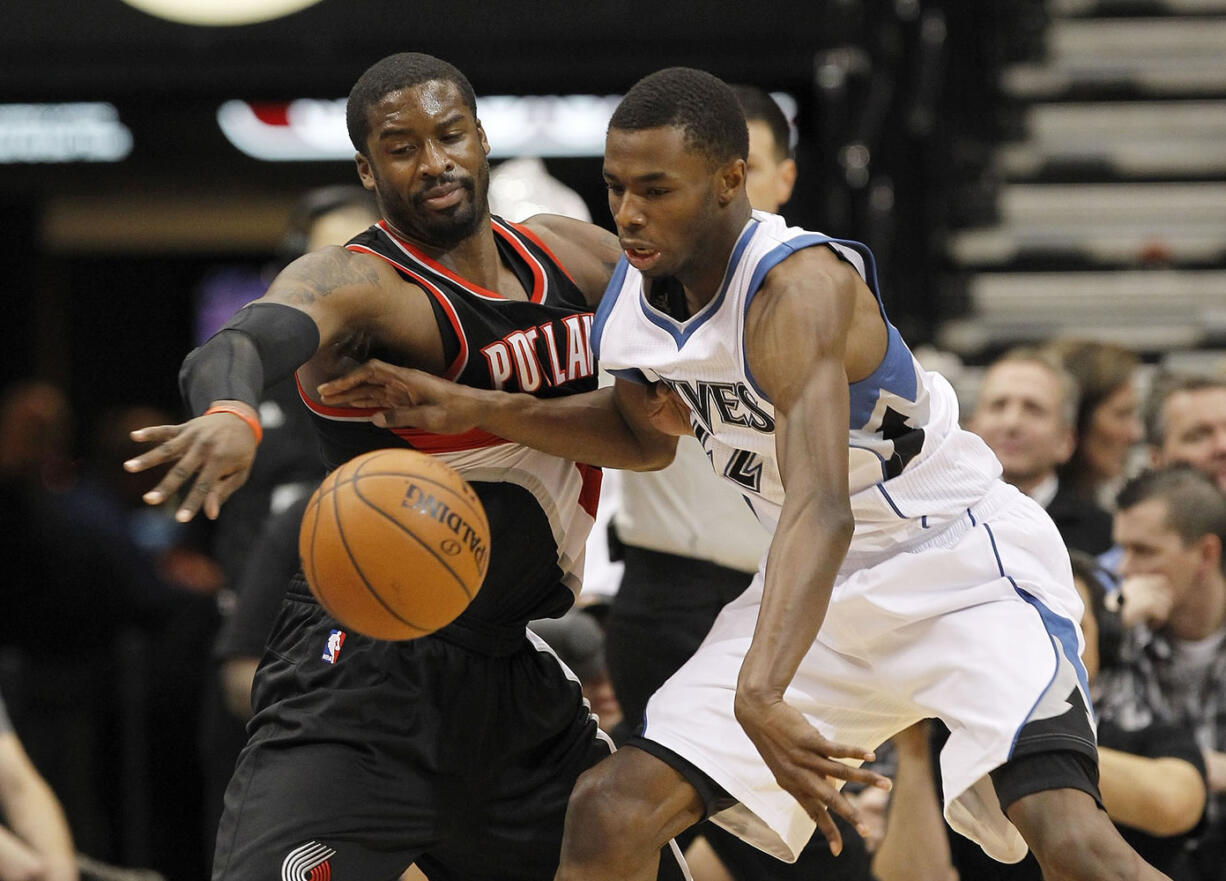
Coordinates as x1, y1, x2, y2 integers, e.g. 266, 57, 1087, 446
609, 67, 749, 165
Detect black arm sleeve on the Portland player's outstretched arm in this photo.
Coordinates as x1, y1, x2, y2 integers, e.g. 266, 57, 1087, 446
179, 303, 319, 415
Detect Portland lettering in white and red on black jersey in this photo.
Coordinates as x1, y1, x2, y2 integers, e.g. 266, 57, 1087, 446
481, 312, 596, 392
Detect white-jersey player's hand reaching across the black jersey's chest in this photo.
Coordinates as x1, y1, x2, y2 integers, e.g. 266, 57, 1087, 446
318, 359, 481, 434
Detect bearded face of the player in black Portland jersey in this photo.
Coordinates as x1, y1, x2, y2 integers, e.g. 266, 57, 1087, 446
357, 80, 489, 248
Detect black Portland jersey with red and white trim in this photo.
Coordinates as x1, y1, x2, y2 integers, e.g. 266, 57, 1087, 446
303, 217, 600, 629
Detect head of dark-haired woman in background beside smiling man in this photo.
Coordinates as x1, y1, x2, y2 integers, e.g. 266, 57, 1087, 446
1047, 339, 1143, 511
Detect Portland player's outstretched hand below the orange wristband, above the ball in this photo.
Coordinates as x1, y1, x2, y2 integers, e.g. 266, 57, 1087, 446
124, 404, 259, 523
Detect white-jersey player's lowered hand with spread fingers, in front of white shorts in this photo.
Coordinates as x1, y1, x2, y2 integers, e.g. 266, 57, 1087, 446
737, 696, 890, 855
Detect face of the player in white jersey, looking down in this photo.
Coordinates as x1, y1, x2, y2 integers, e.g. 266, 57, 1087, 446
604, 126, 722, 277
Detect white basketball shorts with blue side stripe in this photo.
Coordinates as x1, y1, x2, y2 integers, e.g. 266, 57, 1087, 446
642, 484, 1094, 863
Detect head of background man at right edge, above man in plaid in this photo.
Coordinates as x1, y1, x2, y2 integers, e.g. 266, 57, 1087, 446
1145, 375, 1226, 493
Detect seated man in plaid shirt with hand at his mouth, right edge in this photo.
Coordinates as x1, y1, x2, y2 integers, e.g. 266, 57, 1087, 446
1095, 464, 1226, 879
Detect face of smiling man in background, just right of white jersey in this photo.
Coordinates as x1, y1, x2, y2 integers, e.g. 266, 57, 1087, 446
971, 361, 1073, 489
